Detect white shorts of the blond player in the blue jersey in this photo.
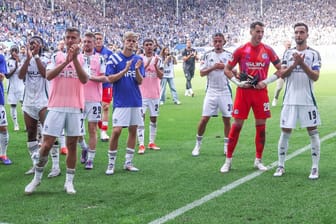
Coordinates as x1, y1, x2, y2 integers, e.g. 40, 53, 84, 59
112, 107, 142, 127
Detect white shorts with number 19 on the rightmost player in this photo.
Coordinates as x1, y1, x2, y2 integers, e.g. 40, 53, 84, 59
280, 105, 321, 129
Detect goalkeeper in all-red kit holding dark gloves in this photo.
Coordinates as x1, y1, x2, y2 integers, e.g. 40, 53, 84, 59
220, 22, 281, 173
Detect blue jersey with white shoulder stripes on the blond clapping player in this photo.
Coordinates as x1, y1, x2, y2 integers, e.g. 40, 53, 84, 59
106, 52, 145, 108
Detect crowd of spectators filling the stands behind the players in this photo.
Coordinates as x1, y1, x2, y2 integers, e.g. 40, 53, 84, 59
0, 0, 336, 51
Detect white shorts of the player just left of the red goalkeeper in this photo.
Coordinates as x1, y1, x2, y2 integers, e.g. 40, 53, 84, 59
202, 94, 232, 117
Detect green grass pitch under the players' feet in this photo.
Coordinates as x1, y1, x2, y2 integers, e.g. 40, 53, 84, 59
0, 62, 336, 224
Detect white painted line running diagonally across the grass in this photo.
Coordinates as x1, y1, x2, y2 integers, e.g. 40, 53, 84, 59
149, 132, 336, 224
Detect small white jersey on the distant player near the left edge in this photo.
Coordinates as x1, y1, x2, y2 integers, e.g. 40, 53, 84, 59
7, 58, 25, 95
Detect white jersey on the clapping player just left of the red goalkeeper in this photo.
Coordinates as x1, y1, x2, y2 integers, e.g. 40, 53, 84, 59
200, 51, 232, 95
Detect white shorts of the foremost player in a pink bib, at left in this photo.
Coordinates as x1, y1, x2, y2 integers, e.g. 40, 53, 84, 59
42, 110, 84, 137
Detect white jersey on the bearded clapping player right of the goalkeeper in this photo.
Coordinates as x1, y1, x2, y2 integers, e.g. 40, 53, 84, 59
282, 47, 321, 106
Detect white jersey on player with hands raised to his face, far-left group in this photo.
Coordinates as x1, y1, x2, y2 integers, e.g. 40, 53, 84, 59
23, 57, 49, 107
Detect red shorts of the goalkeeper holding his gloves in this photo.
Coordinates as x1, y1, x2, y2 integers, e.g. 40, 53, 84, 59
232, 88, 271, 120
